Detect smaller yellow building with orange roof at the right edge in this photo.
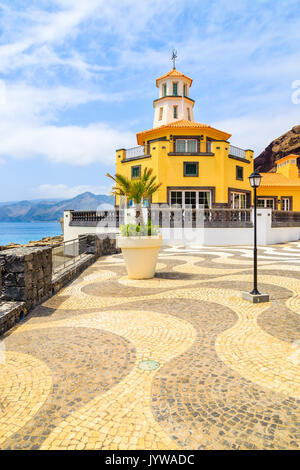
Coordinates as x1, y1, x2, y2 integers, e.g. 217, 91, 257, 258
257, 154, 300, 211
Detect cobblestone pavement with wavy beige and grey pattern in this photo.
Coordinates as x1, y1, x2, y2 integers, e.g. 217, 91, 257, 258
0, 242, 300, 449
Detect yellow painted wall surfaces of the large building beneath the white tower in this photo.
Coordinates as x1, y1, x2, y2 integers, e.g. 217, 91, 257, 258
116, 128, 253, 205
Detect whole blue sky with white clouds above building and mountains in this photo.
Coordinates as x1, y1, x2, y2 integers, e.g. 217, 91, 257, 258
0, 0, 300, 201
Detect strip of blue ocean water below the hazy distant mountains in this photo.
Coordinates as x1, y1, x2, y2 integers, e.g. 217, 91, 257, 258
0, 222, 62, 245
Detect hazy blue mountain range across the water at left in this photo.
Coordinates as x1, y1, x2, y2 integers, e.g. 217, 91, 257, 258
0, 192, 114, 222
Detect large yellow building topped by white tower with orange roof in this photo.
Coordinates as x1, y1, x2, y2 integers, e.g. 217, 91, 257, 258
116, 68, 253, 208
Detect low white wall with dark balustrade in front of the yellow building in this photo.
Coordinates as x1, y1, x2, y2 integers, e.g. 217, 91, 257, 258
64, 208, 300, 246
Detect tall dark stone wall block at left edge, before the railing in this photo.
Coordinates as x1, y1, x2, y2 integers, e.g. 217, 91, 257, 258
0, 247, 52, 309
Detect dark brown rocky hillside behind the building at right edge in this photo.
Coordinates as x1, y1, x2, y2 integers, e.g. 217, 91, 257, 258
254, 126, 300, 172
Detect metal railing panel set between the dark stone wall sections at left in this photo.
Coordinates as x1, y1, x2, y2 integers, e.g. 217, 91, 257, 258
52, 237, 88, 274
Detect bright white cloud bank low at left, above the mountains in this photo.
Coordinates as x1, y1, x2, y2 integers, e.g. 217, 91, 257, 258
0, 83, 136, 165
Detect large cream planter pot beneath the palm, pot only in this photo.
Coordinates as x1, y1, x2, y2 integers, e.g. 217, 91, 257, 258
117, 235, 162, 279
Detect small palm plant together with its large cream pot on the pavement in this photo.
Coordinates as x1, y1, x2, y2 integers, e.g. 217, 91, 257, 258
107, 168, 162, 279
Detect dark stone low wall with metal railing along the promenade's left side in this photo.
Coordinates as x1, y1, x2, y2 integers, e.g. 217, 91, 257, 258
0, 234, 119, 334
